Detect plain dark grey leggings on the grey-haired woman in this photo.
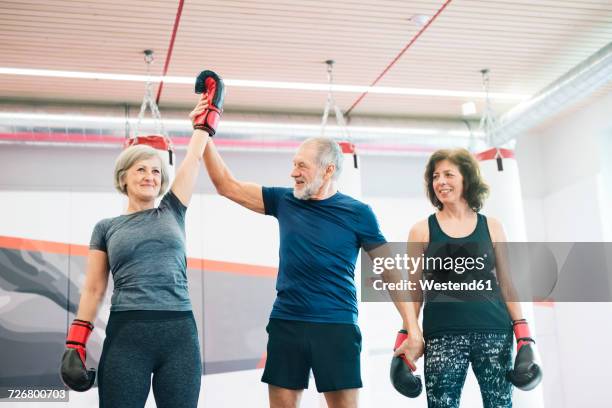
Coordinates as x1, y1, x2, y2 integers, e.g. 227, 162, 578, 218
98, 311, 202, 408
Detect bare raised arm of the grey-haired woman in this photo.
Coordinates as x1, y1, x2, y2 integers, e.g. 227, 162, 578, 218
171, 94, 209, 206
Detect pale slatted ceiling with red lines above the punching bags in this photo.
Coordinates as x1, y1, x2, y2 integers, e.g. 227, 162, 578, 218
0, 0, 612, 118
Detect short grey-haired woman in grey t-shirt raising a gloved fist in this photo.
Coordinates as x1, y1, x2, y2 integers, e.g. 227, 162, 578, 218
61, 71, 223, 408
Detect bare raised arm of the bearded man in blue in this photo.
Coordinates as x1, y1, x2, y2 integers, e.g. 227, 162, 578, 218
204, 139, 265, 214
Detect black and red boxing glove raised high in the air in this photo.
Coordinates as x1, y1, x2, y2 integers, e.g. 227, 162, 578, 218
193, 71, 225, 136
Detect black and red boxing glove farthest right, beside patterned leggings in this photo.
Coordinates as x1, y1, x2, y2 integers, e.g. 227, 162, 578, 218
506, 319, 542, 391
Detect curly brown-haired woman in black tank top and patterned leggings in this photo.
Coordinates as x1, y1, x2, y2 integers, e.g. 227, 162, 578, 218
392, 149, 540, 408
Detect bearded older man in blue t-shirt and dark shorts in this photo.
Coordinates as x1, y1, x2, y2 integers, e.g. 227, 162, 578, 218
204, 138, 413, 408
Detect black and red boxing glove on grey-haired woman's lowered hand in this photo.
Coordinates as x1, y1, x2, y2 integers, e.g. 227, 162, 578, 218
60, 319, 96, 392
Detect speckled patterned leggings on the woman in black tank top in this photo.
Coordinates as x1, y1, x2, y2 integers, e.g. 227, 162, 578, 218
425, 332, 512, 408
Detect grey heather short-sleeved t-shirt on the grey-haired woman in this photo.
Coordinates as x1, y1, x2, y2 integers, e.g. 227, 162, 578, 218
89, 191, 191, 312
